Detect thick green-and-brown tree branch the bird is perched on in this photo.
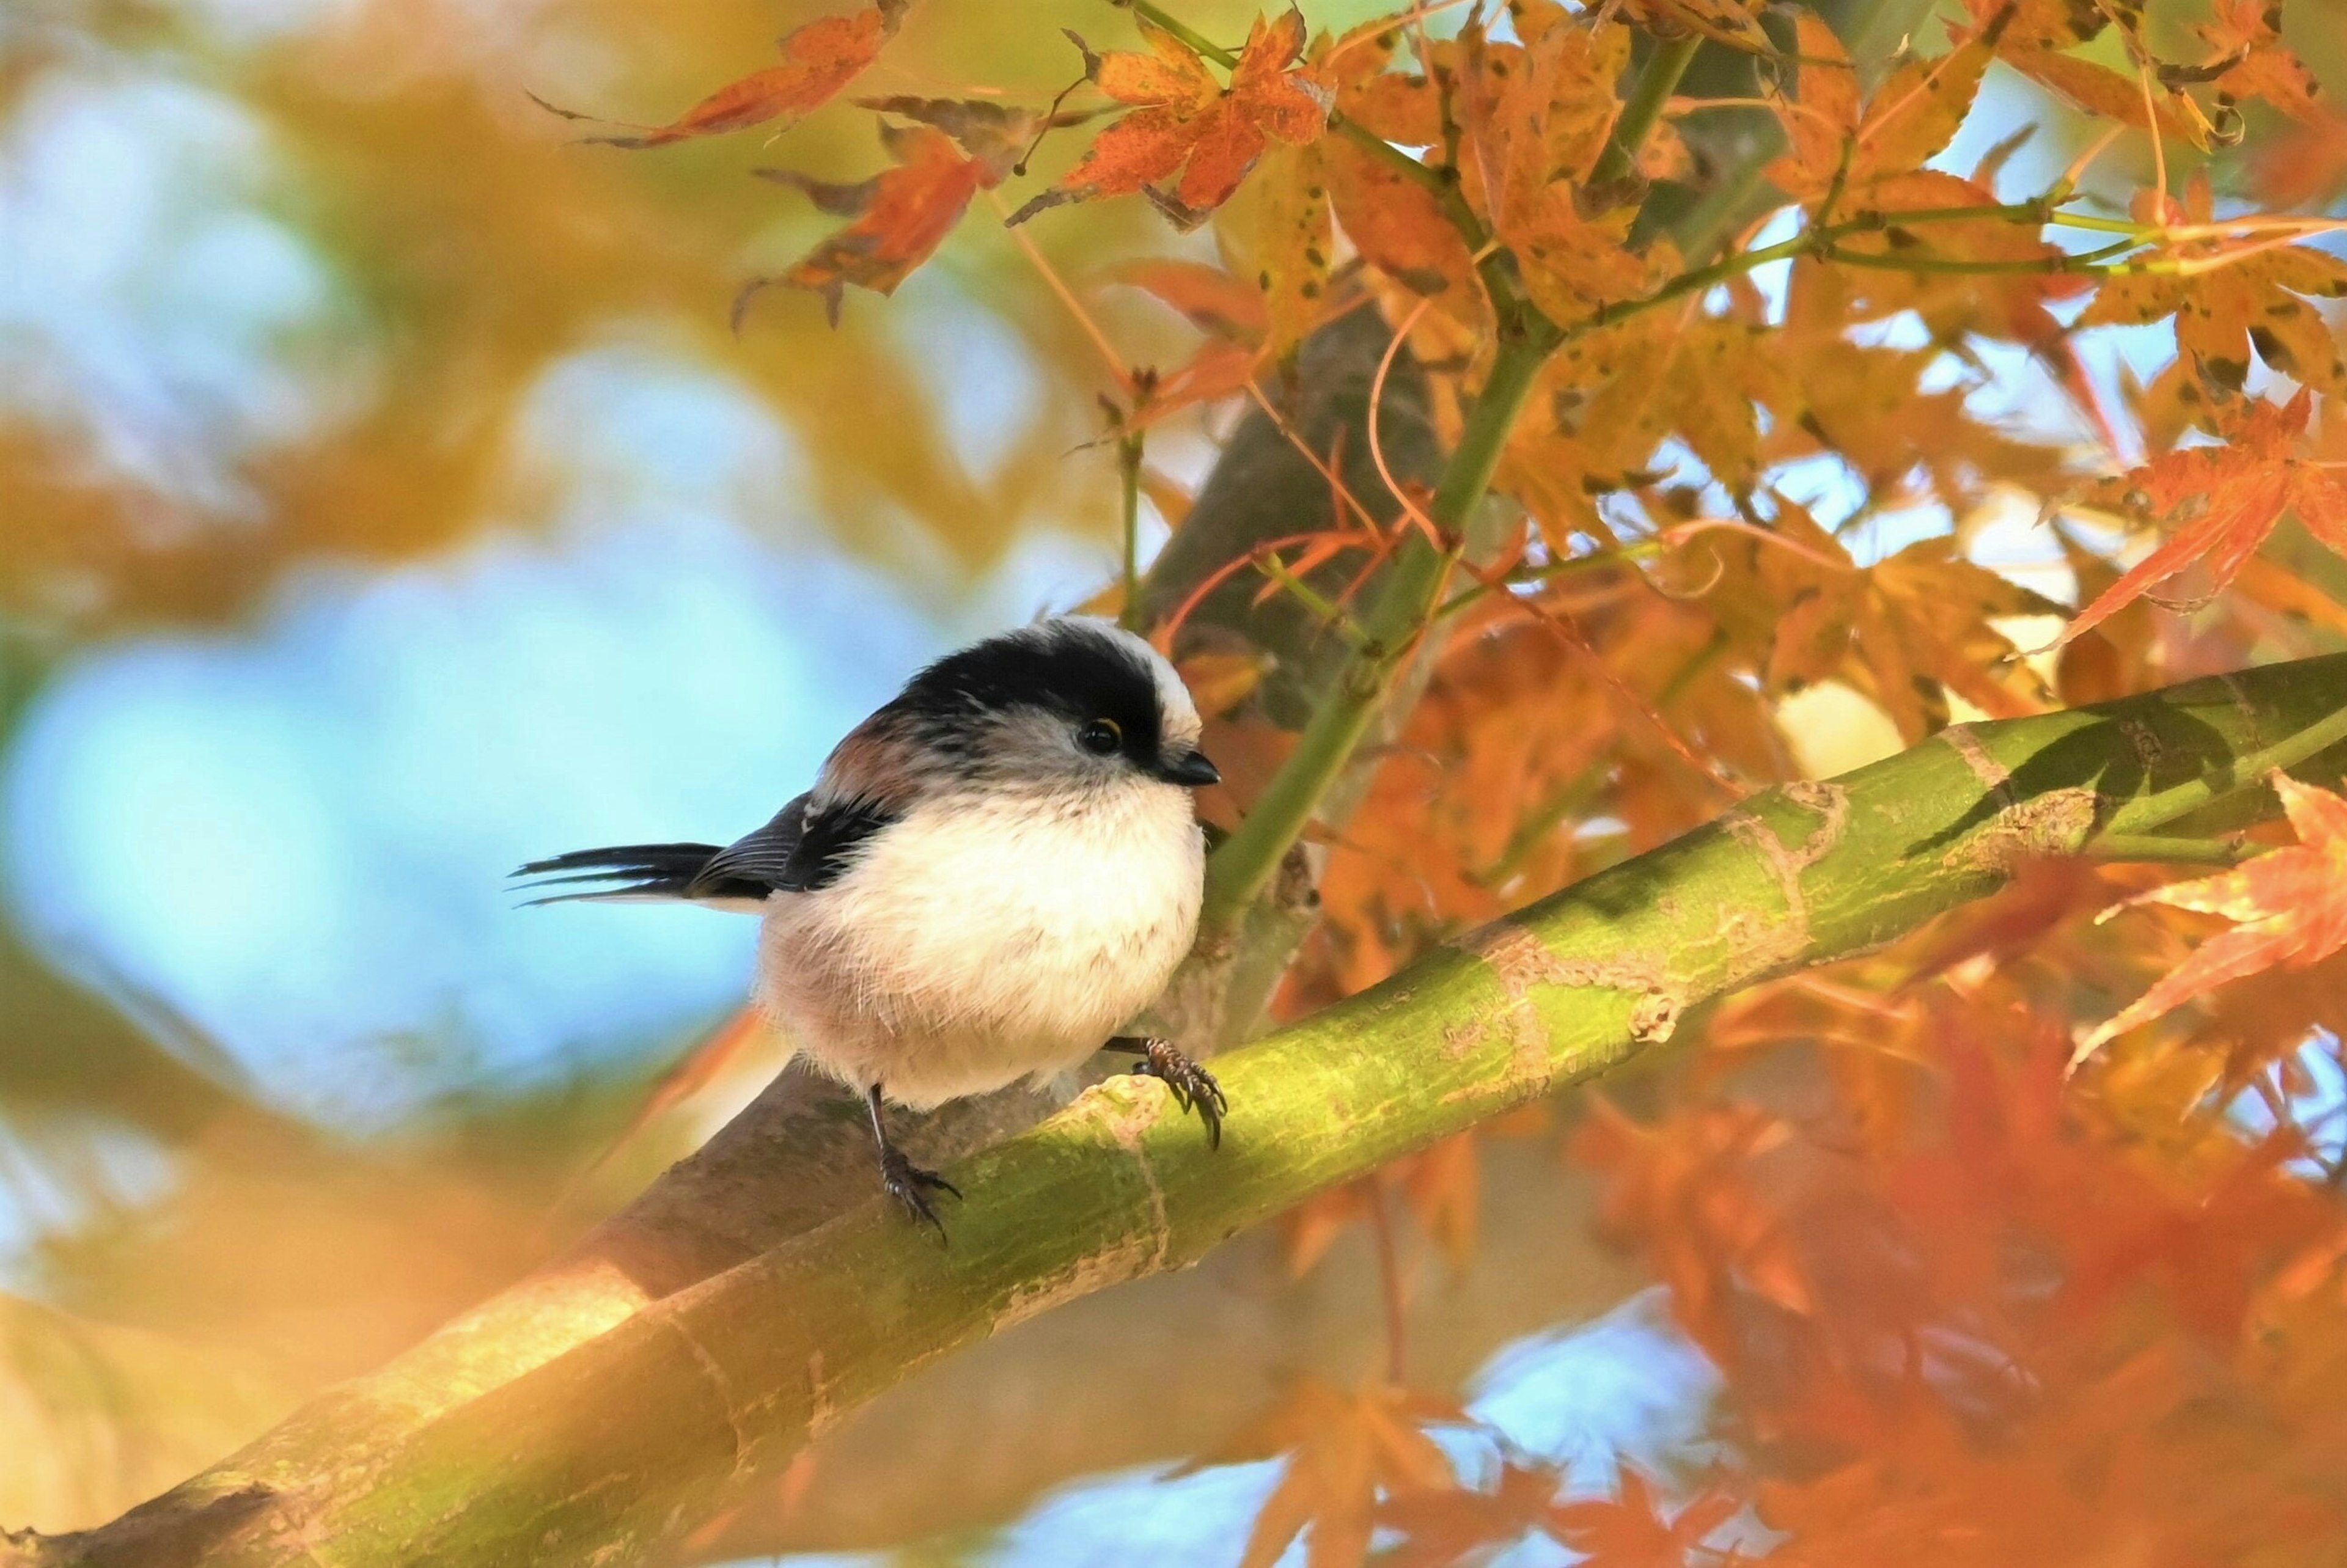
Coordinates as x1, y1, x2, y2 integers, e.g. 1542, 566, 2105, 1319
32, 655, 2347, 1568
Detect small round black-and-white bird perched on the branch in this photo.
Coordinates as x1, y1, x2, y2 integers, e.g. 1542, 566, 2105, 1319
514, 617, 1227, 1228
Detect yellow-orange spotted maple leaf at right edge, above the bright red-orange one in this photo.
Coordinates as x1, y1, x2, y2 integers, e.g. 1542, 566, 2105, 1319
2077, 176, 2347, 397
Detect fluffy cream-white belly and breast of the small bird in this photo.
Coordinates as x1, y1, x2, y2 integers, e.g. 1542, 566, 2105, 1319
758, 782, 1204, 1108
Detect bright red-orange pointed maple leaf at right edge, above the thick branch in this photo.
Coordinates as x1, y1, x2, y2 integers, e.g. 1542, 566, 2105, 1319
2061, 387, 2347, 643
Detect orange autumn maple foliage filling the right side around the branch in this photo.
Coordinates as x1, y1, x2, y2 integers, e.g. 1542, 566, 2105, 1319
13, 0, 2347, 1568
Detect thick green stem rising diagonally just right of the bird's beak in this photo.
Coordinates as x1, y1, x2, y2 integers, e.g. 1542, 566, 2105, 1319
1199, 321, 1559, 932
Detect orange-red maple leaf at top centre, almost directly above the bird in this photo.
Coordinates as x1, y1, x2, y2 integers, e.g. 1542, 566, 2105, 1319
1012, 9, 1333, 228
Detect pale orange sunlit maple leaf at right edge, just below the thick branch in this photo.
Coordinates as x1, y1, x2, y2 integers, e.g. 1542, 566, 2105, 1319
2070, 772, 2347, 1066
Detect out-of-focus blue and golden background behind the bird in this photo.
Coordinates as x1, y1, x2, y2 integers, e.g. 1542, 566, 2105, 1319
13, 0, 2340, 1563
